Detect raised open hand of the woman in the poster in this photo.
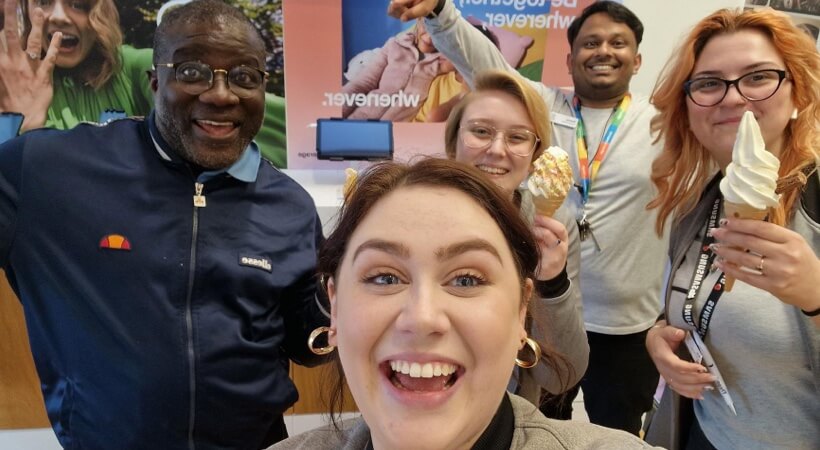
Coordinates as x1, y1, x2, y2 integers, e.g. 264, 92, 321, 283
0, 0, 63, 130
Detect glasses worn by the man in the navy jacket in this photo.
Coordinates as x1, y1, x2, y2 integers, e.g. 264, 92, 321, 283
154, 61, 268, 98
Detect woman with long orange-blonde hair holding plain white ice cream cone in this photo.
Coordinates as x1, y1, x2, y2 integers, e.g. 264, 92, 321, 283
646, 9, 820, 449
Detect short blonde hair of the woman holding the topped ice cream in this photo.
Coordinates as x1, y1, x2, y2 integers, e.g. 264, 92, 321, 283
444, 70, 550, 161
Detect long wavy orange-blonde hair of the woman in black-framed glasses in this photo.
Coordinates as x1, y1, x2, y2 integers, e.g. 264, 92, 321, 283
647, 8, 820, 234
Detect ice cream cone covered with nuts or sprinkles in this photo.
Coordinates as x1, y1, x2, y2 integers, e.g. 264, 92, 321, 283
527, 147, 572, 216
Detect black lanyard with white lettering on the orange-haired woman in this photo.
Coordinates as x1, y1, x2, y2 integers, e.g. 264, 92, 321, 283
683, 196, 726, 338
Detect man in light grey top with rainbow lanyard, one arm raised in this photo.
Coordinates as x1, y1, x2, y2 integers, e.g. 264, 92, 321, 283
388, 0, 667, 434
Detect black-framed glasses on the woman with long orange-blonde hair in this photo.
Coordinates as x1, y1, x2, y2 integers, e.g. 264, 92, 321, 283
683, 69, 789, 107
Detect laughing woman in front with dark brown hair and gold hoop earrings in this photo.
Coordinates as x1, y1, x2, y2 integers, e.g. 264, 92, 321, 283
273, 158, 647, 450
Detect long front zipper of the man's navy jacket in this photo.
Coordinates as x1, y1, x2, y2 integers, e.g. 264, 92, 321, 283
185, 182, 205, 450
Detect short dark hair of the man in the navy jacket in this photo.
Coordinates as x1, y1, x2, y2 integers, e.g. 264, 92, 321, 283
154, 0, 265, 64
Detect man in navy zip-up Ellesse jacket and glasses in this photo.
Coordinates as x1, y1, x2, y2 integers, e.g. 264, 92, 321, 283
0, 0, 328, 449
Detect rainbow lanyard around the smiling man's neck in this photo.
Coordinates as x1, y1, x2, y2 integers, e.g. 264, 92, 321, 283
572, 93, 632, 204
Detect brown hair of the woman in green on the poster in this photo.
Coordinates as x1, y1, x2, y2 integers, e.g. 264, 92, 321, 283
21, 0, 122, 89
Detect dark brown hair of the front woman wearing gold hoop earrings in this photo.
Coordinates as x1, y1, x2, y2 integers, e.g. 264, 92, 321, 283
318, 158, 564, 423
